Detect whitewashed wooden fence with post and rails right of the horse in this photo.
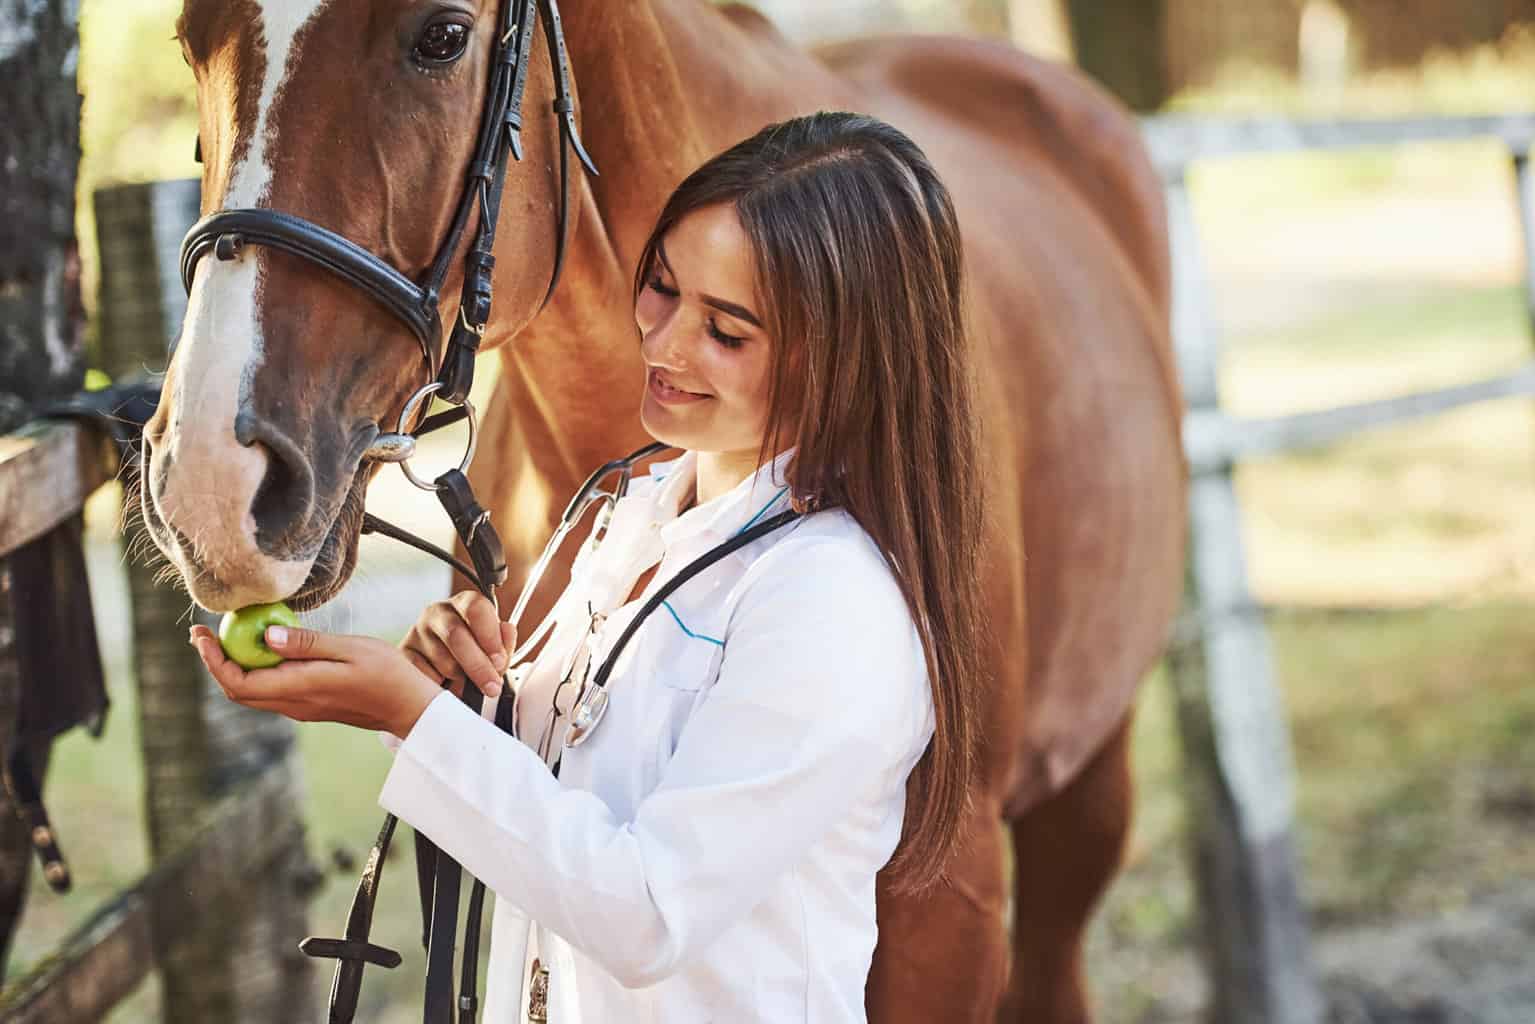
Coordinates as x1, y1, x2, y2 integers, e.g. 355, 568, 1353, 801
1144, 108, 1535, 1024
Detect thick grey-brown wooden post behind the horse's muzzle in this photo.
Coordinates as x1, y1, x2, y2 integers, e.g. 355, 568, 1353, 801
95, 181, 316, 1024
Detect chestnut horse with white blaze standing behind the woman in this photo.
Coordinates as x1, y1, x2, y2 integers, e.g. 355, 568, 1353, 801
140, 0, 1187, 1024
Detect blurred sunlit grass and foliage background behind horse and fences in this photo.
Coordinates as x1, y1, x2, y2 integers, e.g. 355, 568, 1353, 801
11, 0, 1535, 1024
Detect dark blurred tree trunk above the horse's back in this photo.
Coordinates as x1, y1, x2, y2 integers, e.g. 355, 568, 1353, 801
1065, 0, 1168, 112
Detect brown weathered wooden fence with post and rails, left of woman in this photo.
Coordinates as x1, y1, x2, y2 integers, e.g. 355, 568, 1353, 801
0, 181, 318, 1024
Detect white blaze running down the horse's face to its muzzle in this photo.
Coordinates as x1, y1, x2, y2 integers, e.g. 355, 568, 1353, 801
155, 0, 330, 611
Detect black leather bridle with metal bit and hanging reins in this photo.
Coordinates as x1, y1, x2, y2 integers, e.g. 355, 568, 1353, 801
181, 0, 601, 1024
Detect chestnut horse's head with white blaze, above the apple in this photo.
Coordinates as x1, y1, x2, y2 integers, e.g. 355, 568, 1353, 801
141, 0, 560, 611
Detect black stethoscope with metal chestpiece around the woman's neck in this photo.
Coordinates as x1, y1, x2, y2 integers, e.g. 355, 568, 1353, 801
508, 442, 800, 758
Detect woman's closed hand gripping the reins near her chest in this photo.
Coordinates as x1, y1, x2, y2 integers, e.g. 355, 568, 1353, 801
399, 590, 517, 697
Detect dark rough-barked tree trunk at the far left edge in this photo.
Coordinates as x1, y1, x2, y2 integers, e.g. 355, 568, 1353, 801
0, 0, 84, 964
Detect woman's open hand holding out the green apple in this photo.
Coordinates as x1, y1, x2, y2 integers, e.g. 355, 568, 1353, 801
190, 626, 442, 740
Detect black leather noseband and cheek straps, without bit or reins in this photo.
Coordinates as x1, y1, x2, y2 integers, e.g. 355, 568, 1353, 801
181, 0, 597, 405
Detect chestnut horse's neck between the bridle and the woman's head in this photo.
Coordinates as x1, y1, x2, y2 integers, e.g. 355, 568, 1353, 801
488, 0, 837, 494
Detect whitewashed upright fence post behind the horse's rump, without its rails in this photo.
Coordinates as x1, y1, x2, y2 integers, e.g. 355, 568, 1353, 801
1167, 173, 1325, 1024
